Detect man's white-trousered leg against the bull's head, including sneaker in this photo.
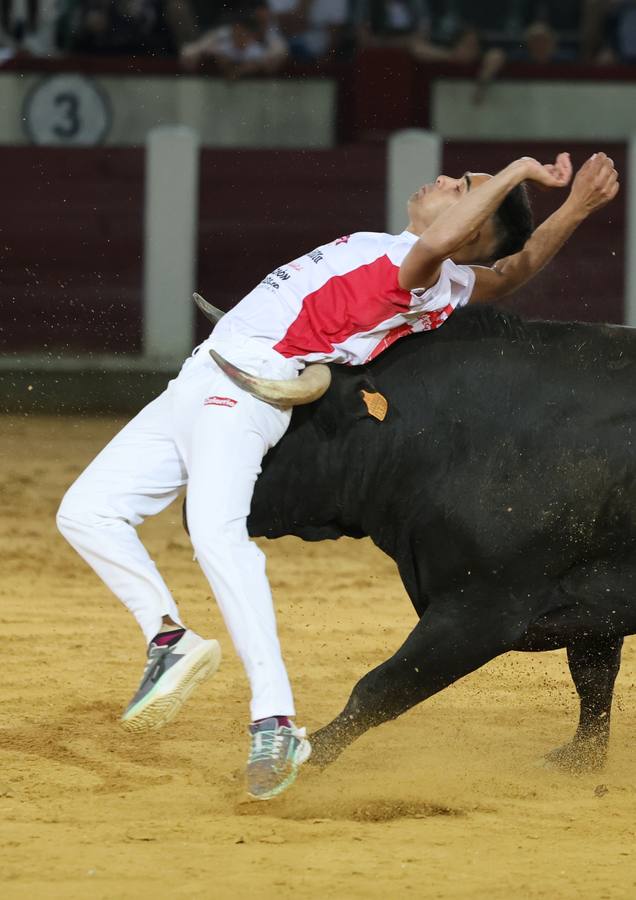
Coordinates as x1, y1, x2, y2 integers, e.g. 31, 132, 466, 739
181, 374, 309, 799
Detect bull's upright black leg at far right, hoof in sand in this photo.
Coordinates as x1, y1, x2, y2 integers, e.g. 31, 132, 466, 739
545, 637, 623, 772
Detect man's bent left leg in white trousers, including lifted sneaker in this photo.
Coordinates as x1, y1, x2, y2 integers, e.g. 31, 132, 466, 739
57, 393, 220, 730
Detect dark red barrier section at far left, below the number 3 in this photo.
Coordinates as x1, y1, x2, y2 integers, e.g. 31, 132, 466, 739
0, 147, 144, 354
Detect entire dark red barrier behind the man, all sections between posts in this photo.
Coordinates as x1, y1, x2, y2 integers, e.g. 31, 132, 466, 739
0, 142, 625, 354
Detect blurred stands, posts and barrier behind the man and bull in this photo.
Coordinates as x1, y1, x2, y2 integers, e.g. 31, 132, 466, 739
0, 0, 636, 412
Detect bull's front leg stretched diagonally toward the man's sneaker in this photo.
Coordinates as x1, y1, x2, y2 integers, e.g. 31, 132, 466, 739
311, 600, 525, 766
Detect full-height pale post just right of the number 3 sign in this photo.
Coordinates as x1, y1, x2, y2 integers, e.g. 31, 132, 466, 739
143, 125, 199, 364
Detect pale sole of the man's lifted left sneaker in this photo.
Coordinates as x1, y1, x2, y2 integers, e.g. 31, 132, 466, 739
120, 641, 221, 733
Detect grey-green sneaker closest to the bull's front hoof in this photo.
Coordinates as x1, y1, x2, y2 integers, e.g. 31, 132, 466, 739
247, 718, 311, 800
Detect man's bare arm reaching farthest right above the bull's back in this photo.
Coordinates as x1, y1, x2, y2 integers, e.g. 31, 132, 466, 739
470, 153, 619, 303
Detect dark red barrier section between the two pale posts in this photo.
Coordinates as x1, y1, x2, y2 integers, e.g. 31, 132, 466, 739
199, 146, 385, 335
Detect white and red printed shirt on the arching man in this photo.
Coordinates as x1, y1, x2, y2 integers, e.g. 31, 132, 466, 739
213, 231, 475, 368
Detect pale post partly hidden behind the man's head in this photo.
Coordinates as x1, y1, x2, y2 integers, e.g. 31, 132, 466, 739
387, 128, 442, 234
